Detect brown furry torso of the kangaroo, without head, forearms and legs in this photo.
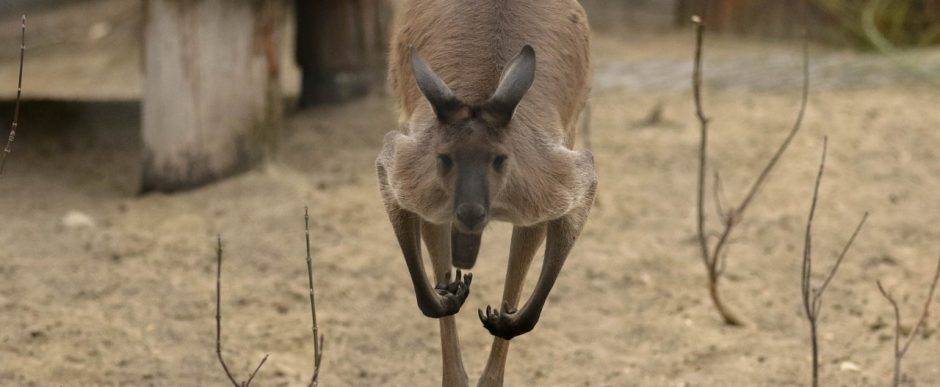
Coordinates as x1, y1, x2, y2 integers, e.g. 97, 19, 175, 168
379, 0, 593, 229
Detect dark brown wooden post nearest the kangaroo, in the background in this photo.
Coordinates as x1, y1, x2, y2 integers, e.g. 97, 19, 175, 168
295, 0, 391, 107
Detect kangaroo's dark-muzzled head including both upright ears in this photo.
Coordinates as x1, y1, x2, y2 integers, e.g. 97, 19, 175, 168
411, 45, 535, 234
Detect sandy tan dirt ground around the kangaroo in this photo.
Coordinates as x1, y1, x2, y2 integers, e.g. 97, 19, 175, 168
0, 0, 940, 386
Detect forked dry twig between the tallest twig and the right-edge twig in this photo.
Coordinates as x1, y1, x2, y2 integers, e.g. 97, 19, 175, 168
800, 138, 868, 387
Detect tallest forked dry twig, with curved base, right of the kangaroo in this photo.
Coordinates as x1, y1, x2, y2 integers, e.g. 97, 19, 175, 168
692, 16, 809, 326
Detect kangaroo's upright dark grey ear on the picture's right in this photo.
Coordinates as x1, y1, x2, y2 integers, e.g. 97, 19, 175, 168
483, 45, 535, 127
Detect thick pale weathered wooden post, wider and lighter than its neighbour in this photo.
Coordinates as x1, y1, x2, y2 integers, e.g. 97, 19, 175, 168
141, 0, 284, 192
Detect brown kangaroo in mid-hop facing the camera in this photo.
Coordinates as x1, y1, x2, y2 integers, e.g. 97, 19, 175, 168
376, 0, 597, 386
